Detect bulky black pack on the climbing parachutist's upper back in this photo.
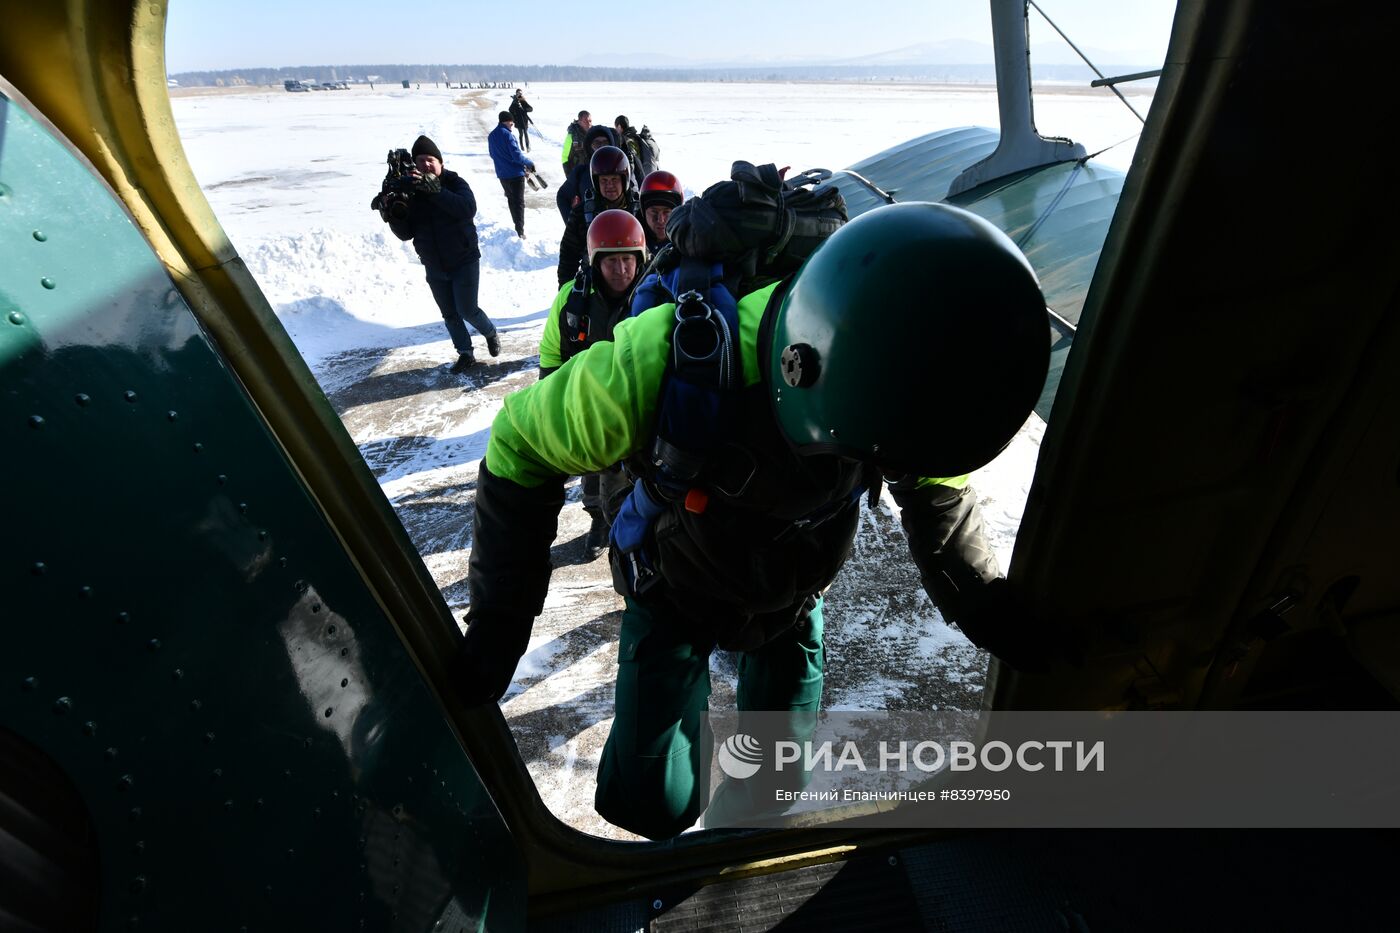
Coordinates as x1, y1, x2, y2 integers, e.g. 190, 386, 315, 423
666, 161, 847, 277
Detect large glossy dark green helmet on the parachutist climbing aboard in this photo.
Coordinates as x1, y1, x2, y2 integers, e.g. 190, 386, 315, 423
764, 203, 1050, 476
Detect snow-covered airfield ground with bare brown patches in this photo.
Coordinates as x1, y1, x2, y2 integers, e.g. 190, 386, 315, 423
172, 84, 1149, 838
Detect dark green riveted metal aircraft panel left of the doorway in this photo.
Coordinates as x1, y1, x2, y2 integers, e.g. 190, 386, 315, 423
0, 87, 525, 930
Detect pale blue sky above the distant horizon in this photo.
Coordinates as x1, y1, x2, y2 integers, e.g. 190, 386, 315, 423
165, 0, 1175, 73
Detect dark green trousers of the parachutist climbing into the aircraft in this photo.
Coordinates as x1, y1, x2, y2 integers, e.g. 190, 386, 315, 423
594, 598, 826, 839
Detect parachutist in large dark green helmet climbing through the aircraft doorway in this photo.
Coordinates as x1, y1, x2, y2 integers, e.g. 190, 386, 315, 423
454, 199, 1050, 839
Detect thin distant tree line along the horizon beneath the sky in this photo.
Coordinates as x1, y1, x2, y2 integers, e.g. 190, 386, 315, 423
171, 64, 1137, 87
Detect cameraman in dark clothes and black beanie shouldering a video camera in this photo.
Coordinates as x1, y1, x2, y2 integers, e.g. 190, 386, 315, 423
379, 136, 501, 373
